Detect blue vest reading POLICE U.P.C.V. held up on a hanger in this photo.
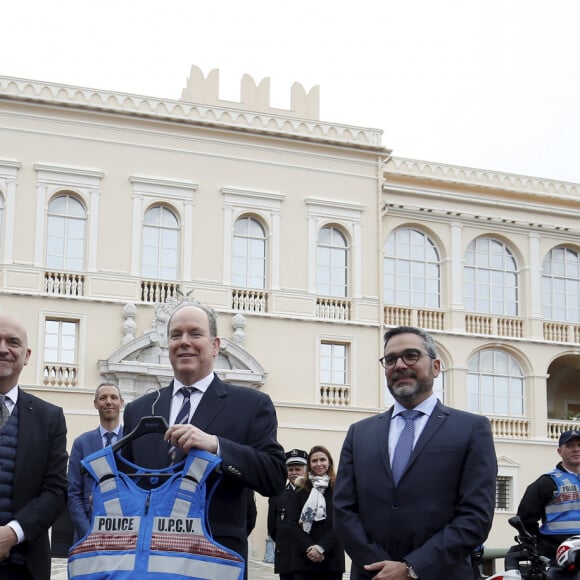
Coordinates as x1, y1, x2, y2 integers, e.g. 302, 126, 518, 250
68, 446, 245, 580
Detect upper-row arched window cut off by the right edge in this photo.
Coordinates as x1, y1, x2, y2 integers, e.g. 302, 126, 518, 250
542, 247, 580, 324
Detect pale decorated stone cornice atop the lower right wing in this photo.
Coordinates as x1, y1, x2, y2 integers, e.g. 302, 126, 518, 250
385, 157, 580, 200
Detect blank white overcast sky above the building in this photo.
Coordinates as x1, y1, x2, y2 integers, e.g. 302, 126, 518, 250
0, 0, 580, 183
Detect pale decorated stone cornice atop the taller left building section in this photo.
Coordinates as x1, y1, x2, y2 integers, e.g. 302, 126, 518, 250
0, 76, 387, 152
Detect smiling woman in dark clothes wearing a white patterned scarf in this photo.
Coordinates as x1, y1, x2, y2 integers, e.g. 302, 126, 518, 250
290, 445, 344, 580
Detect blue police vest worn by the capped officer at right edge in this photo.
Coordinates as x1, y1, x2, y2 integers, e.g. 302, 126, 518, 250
540, 469, 580, 535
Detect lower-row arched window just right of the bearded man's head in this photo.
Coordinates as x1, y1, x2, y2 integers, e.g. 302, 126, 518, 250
467, 348, 524, 416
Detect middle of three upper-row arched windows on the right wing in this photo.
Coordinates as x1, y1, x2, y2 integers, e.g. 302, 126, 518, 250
463, 237, 518, 316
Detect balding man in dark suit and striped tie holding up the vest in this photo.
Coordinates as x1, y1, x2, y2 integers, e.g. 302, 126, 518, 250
124, 303, 286, 572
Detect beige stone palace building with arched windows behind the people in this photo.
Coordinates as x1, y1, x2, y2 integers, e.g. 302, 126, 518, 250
0, 67, 580, 558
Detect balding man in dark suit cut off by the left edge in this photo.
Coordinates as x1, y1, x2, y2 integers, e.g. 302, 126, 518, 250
0, 314, 67, 580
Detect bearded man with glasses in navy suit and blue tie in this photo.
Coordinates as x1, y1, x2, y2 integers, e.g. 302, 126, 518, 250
334, 326, 497, 580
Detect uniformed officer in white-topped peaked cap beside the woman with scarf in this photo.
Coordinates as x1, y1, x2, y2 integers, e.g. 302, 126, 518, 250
268, 449, 308, 580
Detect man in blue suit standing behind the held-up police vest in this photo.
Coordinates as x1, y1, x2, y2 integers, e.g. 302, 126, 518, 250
68, 383, 123, 541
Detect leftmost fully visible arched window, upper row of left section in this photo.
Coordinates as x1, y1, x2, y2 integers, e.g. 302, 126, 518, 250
46, 194, 87, 272
